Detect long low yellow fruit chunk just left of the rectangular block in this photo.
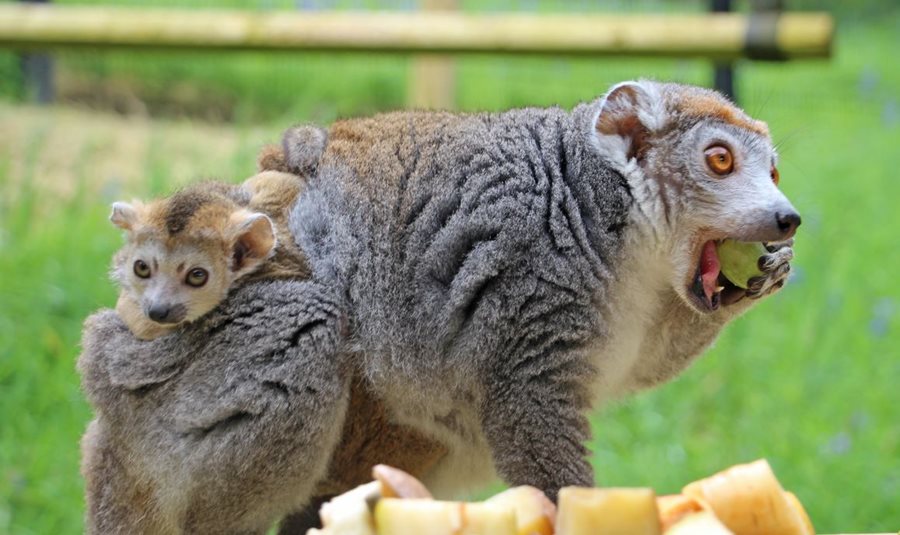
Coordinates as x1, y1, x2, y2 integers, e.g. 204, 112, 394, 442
375, 498, 516, 535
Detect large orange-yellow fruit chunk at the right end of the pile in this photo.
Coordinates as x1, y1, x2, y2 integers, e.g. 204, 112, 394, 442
682, 460, 813, 535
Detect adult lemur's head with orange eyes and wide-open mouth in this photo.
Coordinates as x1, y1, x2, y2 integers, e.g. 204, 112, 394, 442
593, 81, 800, 312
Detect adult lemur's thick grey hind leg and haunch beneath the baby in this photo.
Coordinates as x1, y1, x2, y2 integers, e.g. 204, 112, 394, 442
78, 281, 346, 534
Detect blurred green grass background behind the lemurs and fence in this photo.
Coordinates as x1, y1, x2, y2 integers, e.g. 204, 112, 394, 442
0, 0, 900, 534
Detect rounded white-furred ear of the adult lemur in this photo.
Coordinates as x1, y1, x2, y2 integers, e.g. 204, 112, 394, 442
594, 82, 657, 160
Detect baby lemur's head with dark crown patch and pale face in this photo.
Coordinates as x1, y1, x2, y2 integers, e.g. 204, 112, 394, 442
109, 185, 275, 326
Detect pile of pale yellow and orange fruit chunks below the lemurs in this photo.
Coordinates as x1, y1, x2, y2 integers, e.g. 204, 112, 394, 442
307, 460, 815, 535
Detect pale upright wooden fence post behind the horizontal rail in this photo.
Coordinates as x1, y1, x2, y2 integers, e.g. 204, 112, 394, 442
407, 0, 459, 110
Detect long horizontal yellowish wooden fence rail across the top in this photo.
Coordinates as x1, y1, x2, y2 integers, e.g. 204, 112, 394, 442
0, 4, 834, 60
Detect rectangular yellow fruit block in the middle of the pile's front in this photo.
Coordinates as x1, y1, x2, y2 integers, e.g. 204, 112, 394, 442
556, 487, 660, 535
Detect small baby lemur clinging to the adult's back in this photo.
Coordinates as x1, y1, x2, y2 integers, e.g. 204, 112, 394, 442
110, 126, 325, 340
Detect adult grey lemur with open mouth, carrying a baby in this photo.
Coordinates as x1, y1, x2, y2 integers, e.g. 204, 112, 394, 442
80, 81, 800, 533
